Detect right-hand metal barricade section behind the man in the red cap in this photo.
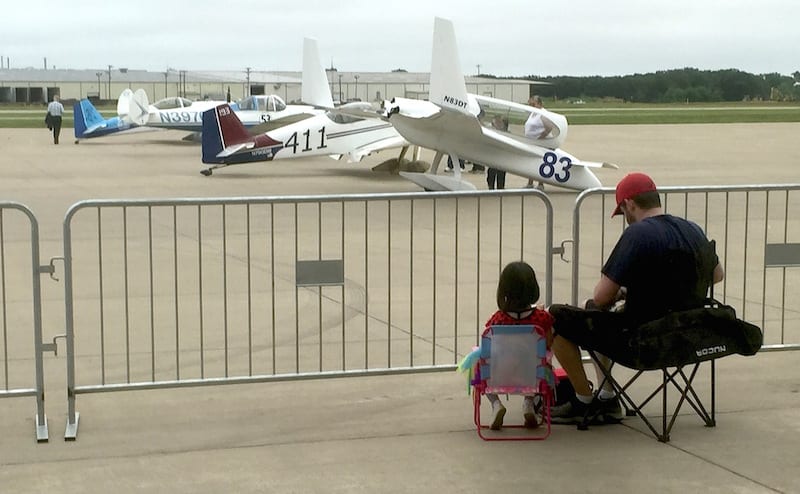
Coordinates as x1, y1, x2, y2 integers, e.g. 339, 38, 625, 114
572, 184, 800, 350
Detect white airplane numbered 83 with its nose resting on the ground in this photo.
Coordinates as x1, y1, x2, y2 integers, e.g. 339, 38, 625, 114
384, 17, 616, 190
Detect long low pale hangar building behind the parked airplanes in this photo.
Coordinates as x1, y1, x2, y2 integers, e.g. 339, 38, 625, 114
0, 67, 543, 104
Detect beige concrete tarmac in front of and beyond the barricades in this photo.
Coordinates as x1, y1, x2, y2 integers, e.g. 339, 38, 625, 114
0, 123, 800, 493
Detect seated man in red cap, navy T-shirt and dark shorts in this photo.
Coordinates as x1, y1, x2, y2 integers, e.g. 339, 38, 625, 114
550, 173, 724, 423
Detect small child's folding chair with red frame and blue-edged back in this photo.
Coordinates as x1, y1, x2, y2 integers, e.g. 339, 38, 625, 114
471, 325, 554, 441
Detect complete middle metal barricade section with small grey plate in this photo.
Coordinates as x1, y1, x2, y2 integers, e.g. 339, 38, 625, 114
64, 190, 558, 439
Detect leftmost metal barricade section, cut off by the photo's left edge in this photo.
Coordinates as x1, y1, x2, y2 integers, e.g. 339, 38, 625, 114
0, 201, 50, 442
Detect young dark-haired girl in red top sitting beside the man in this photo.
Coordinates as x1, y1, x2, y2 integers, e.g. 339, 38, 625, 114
483, 261, 553, 430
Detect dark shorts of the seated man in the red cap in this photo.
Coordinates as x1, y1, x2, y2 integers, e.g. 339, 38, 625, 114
548, 304, 632, 360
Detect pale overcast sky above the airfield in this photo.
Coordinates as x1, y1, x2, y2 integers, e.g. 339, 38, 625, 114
0, 0, 800, 76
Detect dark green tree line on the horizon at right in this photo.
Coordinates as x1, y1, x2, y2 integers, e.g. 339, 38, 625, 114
494, 68, 800, 103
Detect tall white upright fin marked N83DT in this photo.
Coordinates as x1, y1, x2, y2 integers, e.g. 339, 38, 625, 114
429, 17, 471, 113
